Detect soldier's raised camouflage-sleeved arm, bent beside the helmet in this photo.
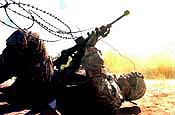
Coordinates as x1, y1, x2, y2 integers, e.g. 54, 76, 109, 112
82, 47, 122, 111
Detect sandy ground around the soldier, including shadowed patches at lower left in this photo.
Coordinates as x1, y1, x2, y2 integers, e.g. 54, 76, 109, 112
0, 80, 175, 115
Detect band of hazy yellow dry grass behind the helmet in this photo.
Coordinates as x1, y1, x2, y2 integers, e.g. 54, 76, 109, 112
104, 51, 175, 79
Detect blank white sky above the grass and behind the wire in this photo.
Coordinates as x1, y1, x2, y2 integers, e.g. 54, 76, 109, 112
0, 0, 175, 58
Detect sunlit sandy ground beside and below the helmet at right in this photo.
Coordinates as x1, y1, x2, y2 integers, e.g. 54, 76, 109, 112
116, 80, 175, 115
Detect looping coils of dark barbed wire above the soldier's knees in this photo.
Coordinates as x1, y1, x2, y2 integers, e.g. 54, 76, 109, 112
0, 0, 79, 42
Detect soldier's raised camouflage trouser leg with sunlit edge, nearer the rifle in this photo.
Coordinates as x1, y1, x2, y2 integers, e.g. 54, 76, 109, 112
27, 32, 53, 81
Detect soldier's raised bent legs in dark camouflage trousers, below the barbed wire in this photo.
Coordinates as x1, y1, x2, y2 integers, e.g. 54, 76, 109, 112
0, 30, 55, 107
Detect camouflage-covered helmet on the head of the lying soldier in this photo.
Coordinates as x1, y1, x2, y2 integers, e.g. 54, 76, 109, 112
117, 72, 146, 101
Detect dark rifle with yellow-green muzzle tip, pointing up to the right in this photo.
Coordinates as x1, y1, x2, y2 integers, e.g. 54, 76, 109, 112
54, 10, 129, 73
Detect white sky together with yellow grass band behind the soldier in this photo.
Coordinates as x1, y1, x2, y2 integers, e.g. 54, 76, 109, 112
0, 0, 175, 77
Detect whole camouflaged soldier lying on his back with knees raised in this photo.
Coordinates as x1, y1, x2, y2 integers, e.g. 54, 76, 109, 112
0, 26, 146, 115
